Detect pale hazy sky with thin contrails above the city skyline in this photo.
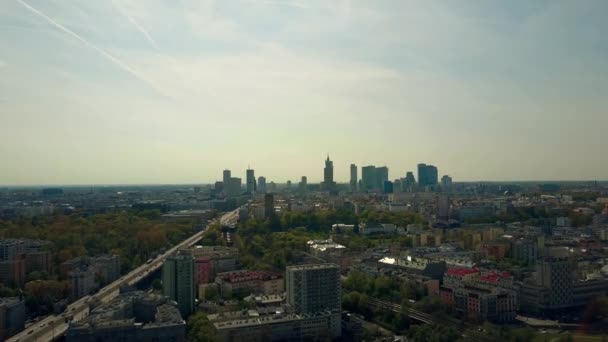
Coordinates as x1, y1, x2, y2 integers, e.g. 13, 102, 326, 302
0, 0, 608, 185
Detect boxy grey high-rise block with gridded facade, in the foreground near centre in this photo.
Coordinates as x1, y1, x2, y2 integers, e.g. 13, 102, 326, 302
285, 264, 342, 314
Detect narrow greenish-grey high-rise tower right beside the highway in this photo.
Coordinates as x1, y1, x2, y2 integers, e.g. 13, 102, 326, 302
163, 251, 195, 318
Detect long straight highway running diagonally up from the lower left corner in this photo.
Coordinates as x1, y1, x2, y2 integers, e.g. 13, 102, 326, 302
8, 209, 238, 342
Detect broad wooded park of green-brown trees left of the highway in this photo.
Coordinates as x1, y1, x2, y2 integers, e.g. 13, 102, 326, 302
0, 210, 193, 272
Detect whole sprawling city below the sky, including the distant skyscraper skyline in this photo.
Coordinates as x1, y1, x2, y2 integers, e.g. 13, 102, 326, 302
0, 155, 608, 341
